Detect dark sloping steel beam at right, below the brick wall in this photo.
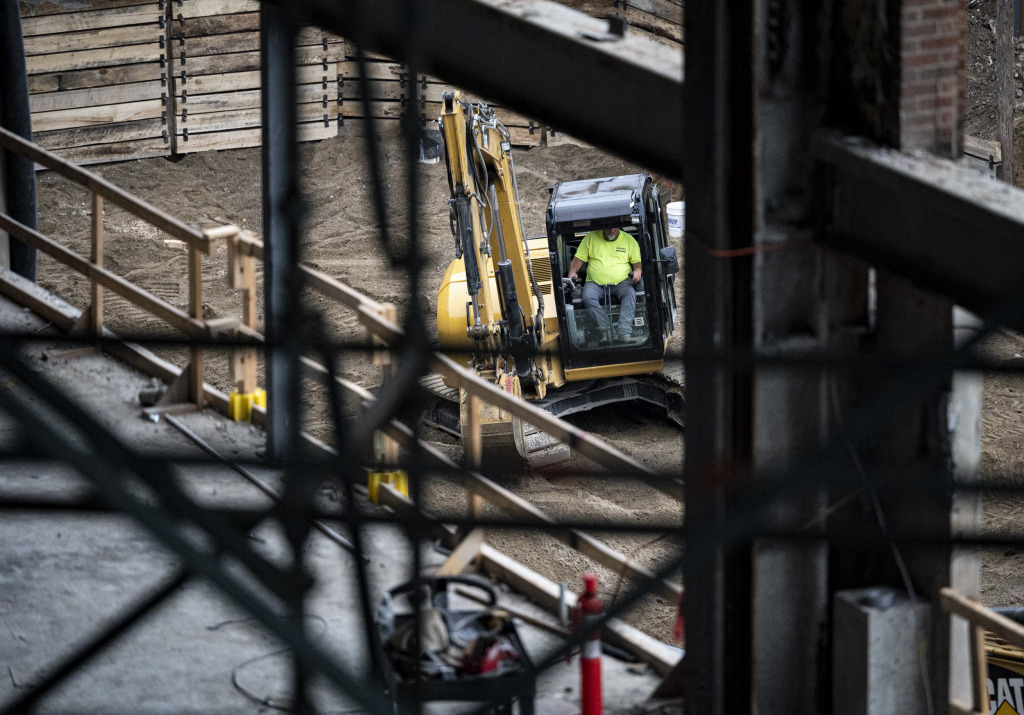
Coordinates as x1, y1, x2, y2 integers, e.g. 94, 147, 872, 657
815, 135, 1024, 329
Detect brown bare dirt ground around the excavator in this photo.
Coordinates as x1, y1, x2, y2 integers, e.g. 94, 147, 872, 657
28, 0, 1024, 642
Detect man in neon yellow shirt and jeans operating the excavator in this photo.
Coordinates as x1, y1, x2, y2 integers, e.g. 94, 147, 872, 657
568, 228, 640, 342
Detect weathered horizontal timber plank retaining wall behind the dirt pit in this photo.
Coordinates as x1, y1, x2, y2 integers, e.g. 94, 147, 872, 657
20, 0, 683, 164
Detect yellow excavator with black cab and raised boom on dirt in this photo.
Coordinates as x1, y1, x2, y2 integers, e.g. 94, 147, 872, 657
428, 92, 683, 465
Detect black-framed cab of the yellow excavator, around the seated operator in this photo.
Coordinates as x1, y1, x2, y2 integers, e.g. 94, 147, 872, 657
547, 174, 678, 380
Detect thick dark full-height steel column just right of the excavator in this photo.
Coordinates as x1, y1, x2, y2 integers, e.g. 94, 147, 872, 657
683, 0, 754, 713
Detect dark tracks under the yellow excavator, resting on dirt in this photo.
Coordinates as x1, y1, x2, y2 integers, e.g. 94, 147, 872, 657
420, 363, 685, 467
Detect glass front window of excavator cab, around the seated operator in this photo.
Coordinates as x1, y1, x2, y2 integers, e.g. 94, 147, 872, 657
558, 225, 650, 352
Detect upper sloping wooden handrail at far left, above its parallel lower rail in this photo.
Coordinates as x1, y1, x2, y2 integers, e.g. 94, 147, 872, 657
0, 127, 210, 255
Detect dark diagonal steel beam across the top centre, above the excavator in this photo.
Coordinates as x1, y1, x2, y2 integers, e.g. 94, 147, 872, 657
263, 0, 683, 177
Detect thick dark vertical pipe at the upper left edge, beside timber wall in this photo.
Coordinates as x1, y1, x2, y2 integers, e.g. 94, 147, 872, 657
0, 0, 37, 282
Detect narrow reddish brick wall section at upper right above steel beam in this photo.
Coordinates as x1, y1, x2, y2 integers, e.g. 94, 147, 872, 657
899, 0, 967, 156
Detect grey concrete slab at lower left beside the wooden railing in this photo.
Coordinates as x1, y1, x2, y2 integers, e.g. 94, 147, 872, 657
0, 288, 660, 715
